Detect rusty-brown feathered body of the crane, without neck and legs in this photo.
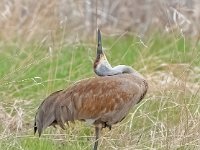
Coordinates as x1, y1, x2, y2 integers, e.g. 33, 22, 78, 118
34, 74, 147, 135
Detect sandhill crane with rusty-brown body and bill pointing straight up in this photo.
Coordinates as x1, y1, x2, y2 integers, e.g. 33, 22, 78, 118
34, 30, 148, 150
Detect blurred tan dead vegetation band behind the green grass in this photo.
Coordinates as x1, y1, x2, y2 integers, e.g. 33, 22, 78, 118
0, 0, 200, 41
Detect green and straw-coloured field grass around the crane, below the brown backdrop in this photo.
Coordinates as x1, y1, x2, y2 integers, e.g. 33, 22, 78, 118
0, 33, 200, 150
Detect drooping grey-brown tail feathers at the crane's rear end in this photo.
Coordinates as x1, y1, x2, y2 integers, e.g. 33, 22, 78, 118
34, 91, 73, 136
